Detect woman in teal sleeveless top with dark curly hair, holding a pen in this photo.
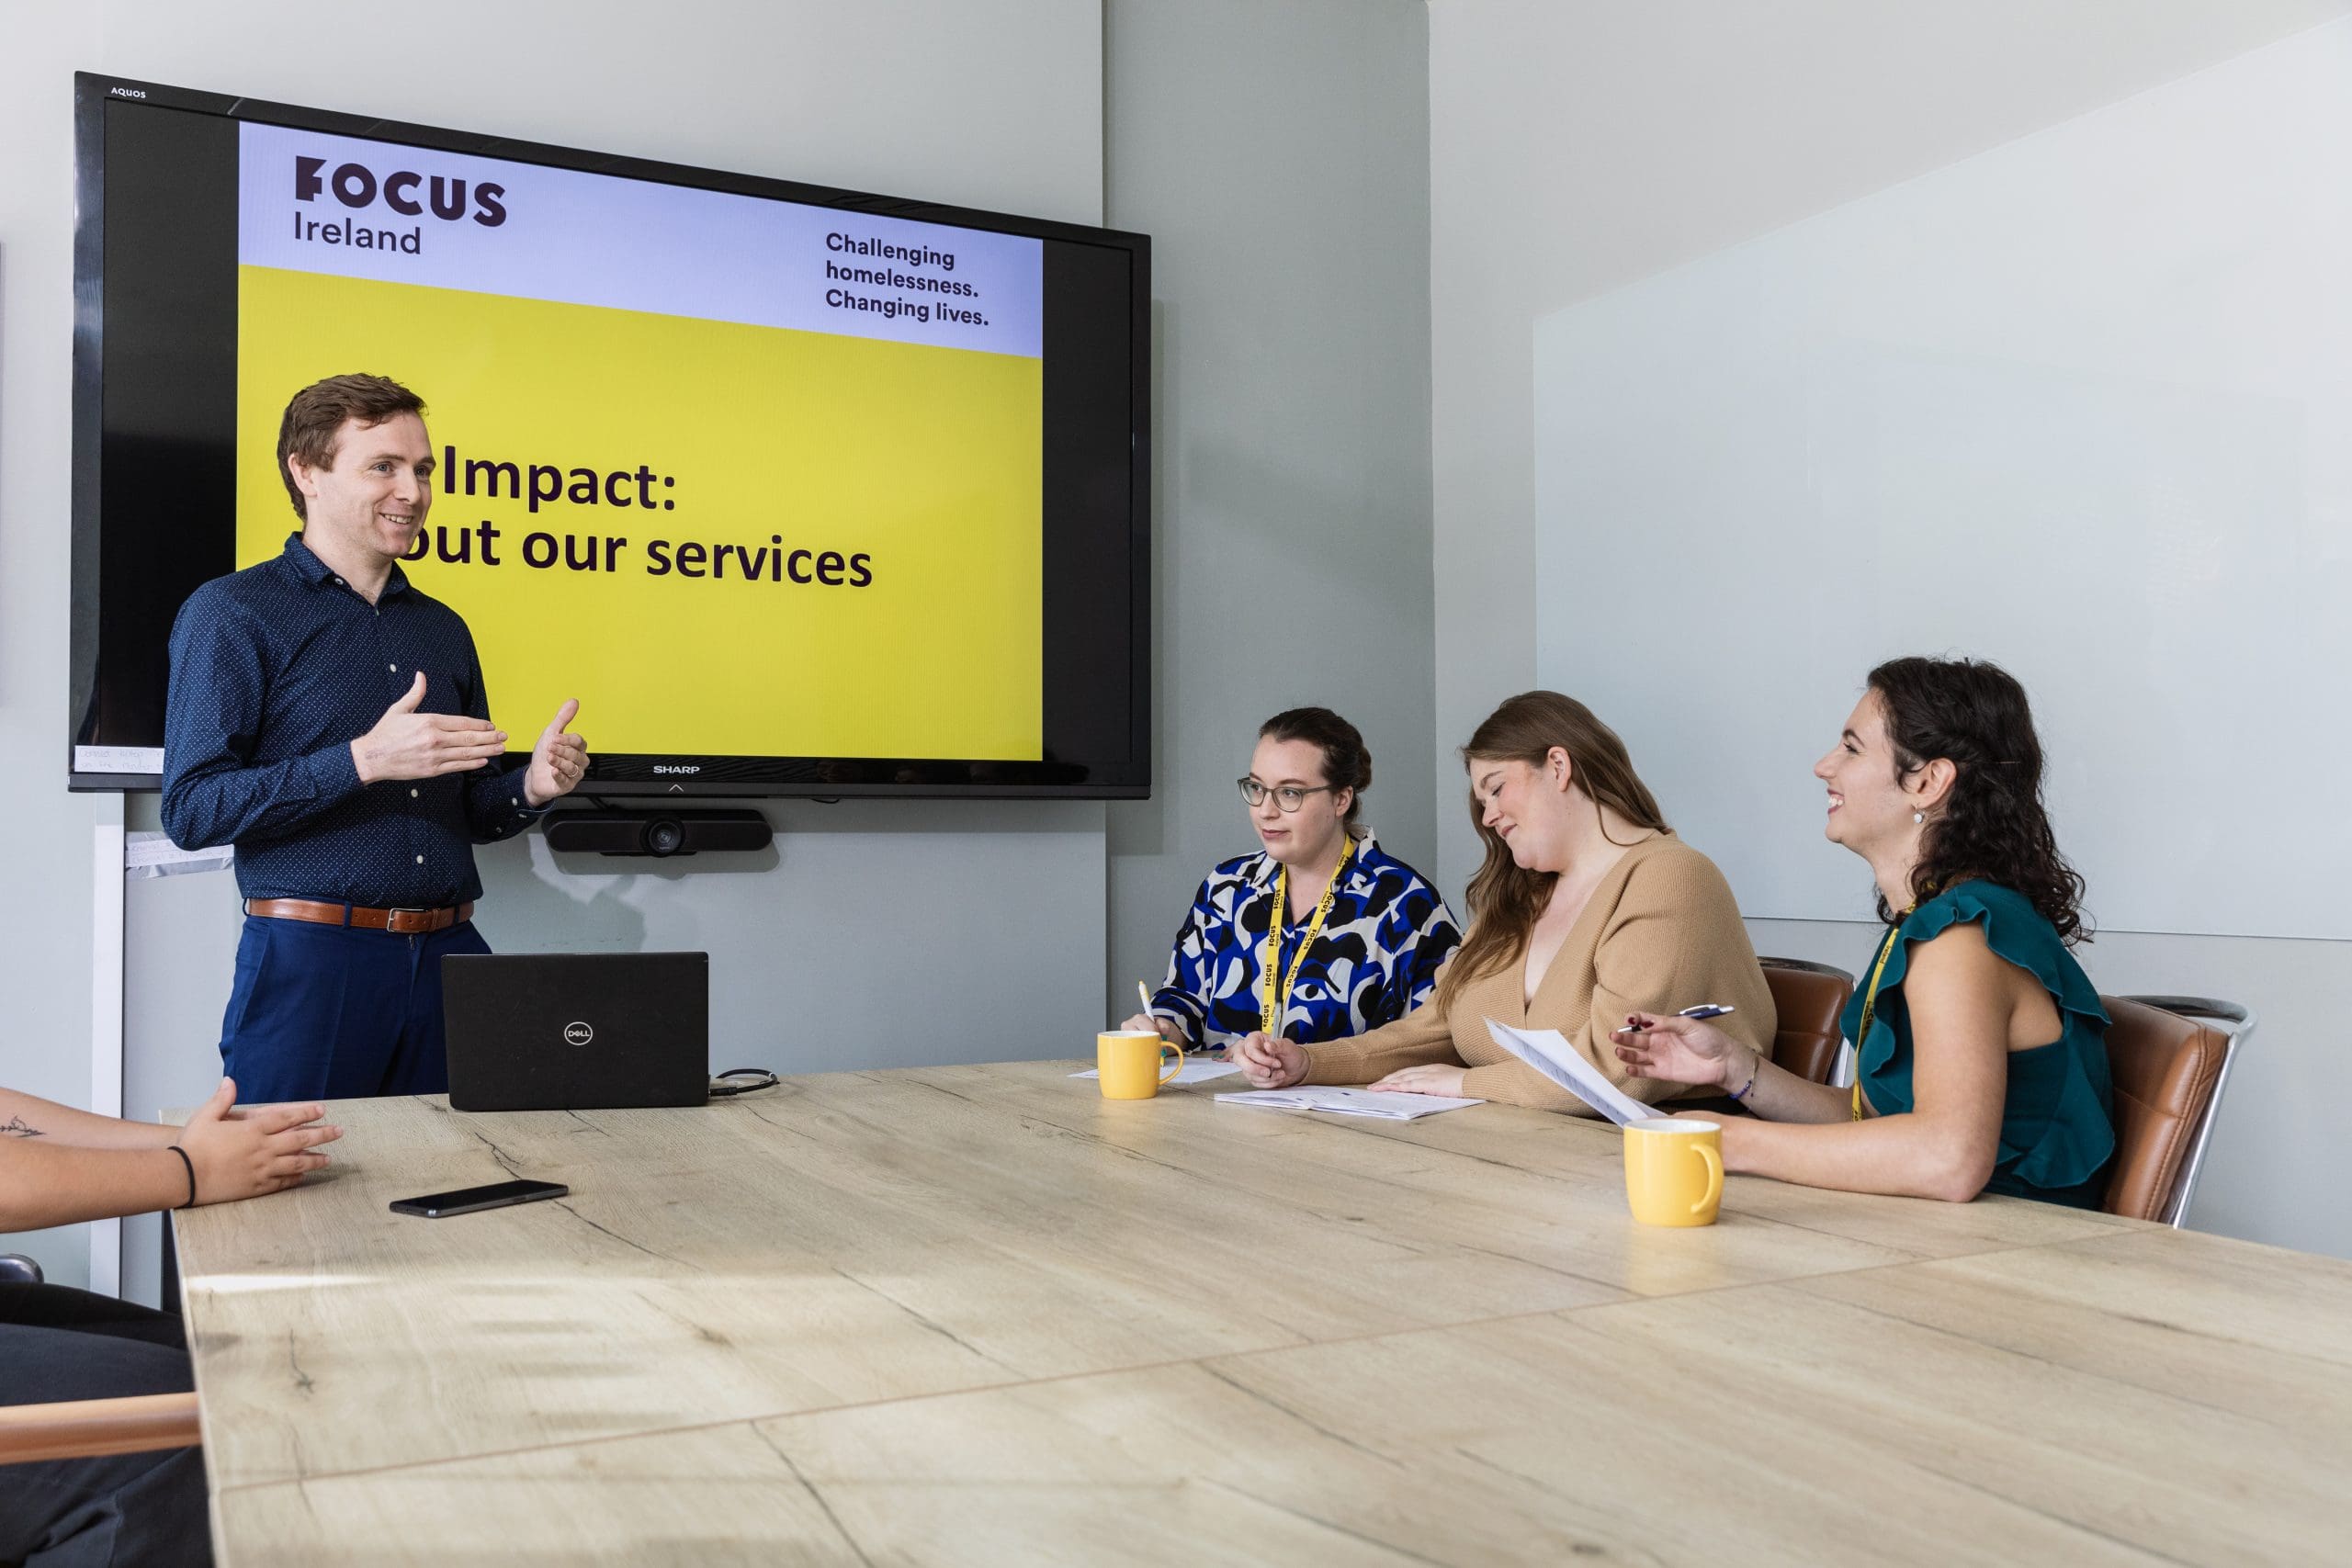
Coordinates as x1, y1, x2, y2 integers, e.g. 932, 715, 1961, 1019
1618, 659, 2114, 1208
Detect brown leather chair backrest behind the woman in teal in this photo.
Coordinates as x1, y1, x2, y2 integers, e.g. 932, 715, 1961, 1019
2100, 997, 2253, 1224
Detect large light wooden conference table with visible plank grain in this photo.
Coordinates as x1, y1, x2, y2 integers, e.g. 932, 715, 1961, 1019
176, 1063, 2352, 1568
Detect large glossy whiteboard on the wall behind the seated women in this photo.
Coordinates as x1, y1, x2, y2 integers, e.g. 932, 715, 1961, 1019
1533, 21, 2352, 938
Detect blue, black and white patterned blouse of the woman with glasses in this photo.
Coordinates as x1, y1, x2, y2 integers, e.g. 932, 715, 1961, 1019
1152, 835, 1463, 1051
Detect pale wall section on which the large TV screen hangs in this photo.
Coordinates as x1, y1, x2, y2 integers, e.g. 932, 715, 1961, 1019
0, 0, 1105, 1283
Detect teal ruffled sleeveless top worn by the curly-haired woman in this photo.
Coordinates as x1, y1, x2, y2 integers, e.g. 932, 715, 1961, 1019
1844, 882, 2114, 1208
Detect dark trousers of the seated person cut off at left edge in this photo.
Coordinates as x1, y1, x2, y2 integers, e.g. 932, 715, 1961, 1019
0, 1283, 211, 1568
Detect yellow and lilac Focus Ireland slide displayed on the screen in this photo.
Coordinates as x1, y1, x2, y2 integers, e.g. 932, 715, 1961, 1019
238, 125, 1045, 761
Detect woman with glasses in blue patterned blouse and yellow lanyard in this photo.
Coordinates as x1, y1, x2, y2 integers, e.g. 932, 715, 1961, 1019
1125, 707, 1461, 1051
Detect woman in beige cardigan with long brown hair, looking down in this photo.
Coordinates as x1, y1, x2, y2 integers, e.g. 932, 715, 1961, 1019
1230, 691, 1776, 1112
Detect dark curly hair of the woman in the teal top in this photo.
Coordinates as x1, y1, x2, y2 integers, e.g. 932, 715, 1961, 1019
1870, 659, 2091, 947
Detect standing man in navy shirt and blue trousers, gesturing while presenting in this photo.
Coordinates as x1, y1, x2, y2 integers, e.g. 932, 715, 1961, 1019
163, 376, 588, 1100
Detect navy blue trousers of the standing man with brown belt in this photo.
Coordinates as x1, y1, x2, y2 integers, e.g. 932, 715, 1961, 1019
221, 915, 489, 1105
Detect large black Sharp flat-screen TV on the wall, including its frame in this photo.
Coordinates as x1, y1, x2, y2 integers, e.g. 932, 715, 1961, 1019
68, 75, 1150, 797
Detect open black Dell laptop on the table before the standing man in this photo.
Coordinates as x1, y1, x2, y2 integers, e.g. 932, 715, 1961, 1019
442, 952, 710, 1110
